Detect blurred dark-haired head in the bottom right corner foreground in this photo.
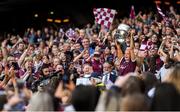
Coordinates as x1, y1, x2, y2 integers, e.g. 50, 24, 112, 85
151, 83, 180, 111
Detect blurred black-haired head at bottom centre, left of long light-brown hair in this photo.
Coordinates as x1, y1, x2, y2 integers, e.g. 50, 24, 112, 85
71, 85, 100, 111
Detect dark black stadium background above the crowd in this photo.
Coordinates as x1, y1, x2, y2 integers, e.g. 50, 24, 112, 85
0, 0, 179, 34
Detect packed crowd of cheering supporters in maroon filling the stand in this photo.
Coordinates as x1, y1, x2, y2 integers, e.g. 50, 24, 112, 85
0, 4, 180, 111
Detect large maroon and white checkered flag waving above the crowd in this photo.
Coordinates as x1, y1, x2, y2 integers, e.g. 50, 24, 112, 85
93, 8, 116, 28
